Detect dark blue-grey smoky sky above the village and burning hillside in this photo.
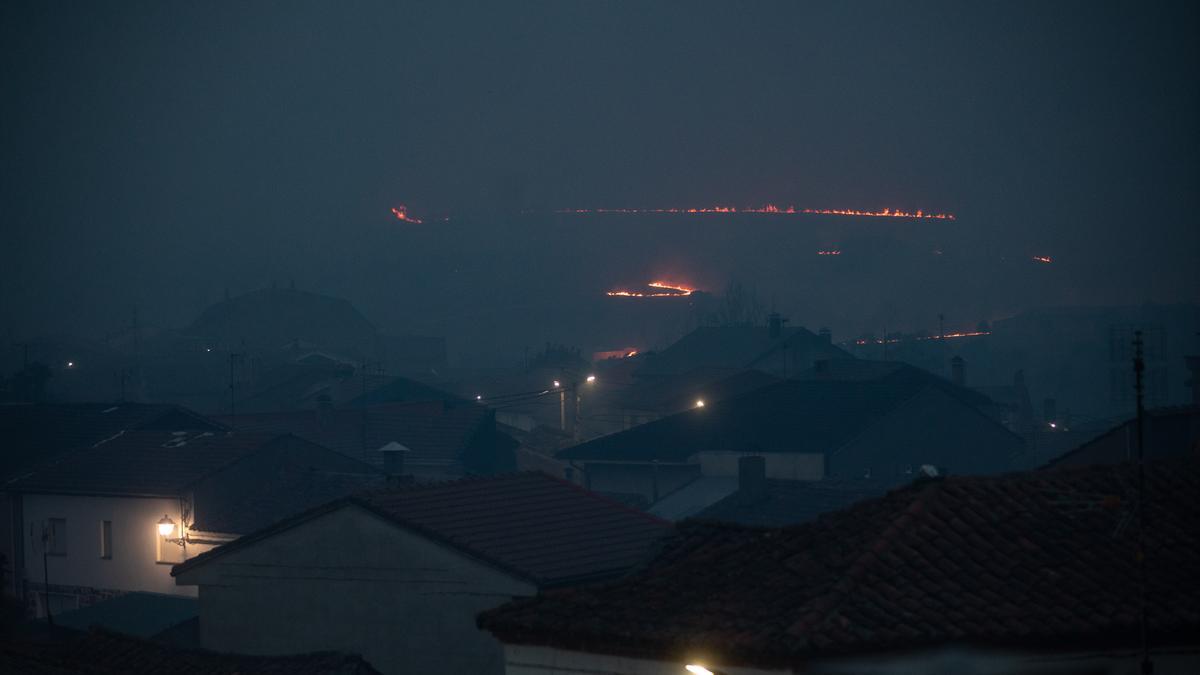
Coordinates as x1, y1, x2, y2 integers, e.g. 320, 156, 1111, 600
0, 0, 1200, 357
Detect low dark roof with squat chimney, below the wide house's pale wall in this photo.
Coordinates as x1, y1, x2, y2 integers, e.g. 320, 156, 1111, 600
696, 478, 892, 527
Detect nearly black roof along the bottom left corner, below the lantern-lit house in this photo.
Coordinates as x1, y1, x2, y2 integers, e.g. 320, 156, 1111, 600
0, 629, 379, 675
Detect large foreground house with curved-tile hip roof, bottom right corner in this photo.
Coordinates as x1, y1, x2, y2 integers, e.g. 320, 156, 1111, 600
479, 461, 1200, 675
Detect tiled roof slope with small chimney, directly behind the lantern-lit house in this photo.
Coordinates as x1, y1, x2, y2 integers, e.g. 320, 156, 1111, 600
218, 401, 490, 476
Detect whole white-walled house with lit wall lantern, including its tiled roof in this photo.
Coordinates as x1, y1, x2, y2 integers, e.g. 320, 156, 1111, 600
4, 431, 383, 616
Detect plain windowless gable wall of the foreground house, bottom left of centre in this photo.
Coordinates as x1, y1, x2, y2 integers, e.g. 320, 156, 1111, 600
178, 507, 536, 674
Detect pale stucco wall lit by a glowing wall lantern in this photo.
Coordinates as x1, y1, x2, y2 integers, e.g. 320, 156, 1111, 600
22, 487, 209, 605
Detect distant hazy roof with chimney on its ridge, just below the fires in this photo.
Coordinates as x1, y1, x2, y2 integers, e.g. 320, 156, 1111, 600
637, 325, 851, 376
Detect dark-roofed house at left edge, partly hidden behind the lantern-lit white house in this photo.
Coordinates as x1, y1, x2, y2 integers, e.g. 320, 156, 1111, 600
0, 402, 226, 595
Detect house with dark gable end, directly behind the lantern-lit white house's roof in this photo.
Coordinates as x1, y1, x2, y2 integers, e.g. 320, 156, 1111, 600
217, 400, 517, 480
